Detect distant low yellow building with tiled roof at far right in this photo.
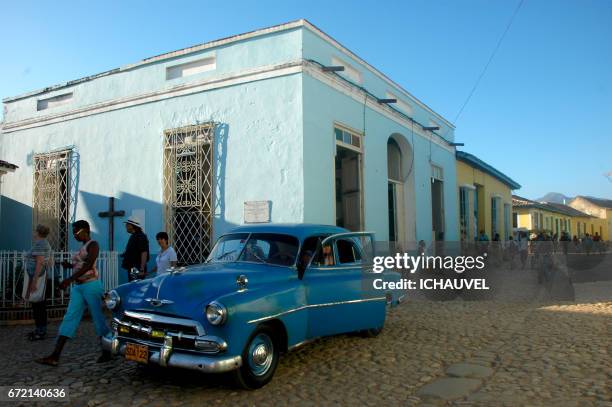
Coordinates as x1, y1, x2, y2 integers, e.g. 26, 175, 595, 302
512, 195, 608, 240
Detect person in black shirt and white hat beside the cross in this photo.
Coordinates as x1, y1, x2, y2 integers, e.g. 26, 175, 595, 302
121, 216, 149, 281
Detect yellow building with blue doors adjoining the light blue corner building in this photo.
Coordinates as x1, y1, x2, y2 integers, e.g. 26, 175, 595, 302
456, 151, 521, 241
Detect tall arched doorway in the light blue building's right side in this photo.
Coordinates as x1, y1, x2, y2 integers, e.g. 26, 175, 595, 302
387, 134, 416, 249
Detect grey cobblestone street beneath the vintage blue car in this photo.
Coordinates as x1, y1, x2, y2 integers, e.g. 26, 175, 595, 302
0, 282, 612, 406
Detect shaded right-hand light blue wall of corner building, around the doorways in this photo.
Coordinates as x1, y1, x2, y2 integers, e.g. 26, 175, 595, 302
303, 30, 458, 242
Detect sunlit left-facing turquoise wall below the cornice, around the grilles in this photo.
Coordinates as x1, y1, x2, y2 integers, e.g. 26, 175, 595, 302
0, 74, 303, 252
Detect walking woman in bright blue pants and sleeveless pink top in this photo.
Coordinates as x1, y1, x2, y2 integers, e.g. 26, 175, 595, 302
36, 220, 111, 366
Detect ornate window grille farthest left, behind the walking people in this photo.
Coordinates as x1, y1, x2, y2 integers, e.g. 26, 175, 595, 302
32, 150, 76, 251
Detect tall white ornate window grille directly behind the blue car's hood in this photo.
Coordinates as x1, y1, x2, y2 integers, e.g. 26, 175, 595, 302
164, 123, 215, 265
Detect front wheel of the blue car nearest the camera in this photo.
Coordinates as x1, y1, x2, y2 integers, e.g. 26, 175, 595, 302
232, 325, 280, 390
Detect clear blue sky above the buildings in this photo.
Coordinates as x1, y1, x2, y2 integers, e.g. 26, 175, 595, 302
0, 0, 612, 198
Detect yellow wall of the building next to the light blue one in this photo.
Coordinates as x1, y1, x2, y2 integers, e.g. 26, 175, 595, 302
456, 160, 512, 239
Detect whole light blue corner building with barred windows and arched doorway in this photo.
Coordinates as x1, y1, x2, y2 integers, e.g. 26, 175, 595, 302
0, 20, 459, 262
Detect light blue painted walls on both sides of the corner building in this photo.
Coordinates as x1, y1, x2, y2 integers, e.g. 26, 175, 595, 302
0, 24, 458, 255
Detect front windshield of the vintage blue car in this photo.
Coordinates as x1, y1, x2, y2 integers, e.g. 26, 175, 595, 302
206, 233, 299, 266
